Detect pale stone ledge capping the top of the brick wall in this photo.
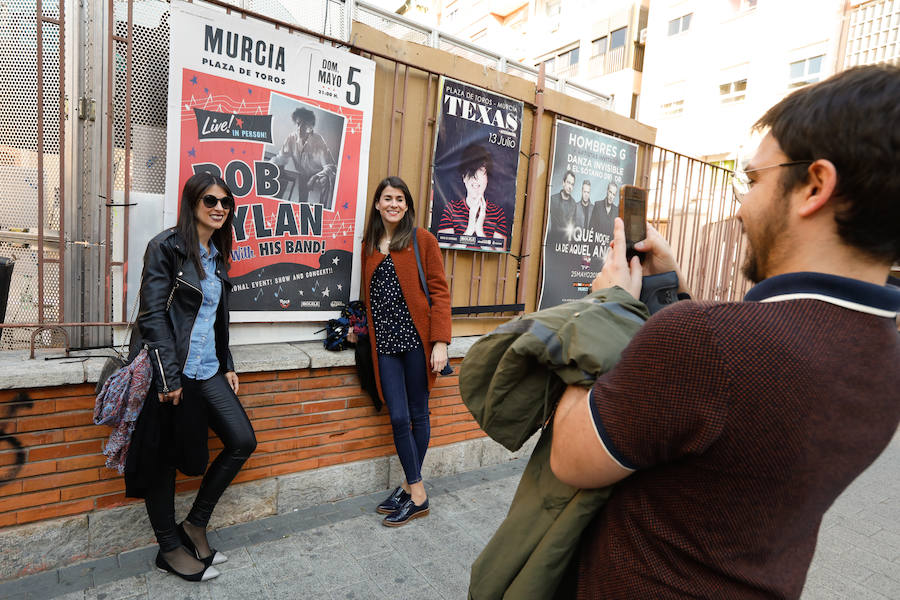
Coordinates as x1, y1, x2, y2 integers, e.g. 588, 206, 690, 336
0, 336, 481, 390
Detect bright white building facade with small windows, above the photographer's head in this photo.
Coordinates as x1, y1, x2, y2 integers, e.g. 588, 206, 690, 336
639, 0, 845, 163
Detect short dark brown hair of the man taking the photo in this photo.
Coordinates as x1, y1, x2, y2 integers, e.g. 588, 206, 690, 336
756, 65, 900, 262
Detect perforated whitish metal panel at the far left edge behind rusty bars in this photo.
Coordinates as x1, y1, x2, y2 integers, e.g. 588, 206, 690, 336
0, 0, 65, 349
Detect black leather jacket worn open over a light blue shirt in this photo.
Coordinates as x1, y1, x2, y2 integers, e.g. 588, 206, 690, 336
129, 228, 234, 392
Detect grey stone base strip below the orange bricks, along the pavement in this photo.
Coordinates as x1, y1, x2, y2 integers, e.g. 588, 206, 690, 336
0, 434, 538, 580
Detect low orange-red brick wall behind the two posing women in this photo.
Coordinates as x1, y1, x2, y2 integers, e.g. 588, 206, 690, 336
0, 360, 484, 527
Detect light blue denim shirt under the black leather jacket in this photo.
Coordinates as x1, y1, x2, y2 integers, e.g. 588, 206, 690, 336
184, 243, 222, 381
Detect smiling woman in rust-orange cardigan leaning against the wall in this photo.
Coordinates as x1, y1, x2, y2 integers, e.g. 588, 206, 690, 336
360, 177, 450, 527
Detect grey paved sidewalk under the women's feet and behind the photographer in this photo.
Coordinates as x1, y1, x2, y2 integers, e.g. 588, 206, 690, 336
0, 434, 900, 600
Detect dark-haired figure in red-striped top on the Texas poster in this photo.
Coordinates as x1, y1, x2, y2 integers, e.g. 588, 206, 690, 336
438, 144, 509, 249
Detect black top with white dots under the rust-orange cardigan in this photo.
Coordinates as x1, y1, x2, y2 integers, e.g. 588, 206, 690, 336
369, 255, 421, 354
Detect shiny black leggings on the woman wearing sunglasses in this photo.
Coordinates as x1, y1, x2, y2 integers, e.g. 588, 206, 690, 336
144, 373, 256, 552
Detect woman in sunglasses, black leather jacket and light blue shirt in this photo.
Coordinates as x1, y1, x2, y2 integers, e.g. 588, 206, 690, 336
125, 173, 256, 581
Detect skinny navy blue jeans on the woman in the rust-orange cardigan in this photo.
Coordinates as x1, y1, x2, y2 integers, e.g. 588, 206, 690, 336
378, 346, 431, 483
